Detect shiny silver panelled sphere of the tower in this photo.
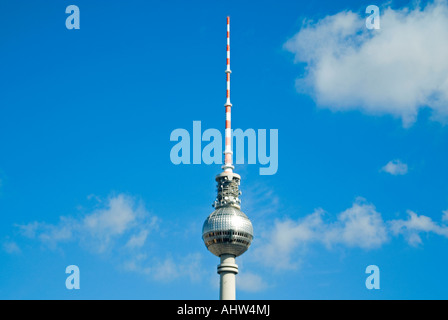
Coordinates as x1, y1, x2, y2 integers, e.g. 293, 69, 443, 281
202, 206, 254, 257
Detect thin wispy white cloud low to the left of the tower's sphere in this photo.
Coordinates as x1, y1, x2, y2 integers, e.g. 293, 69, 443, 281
12, 194, 208, 282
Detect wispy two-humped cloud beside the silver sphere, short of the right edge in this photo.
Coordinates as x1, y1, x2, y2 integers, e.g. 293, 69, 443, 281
254, 198, 388, 269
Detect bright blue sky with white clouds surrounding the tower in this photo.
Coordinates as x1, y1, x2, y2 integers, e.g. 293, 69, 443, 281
0, 0, 448, 299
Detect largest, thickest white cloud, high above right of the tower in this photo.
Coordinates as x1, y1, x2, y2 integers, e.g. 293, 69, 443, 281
285, 1, 448, 126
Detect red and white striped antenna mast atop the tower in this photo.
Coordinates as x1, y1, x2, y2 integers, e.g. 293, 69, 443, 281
222, 17, 234, 173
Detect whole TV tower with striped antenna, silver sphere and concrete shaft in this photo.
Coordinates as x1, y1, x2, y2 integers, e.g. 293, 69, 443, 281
202, 17, 254, 300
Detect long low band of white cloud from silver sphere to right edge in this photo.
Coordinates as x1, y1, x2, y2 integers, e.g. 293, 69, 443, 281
252, 198, 448, 270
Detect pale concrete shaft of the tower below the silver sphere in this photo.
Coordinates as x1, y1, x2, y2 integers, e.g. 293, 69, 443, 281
218, 254, 238, 300
